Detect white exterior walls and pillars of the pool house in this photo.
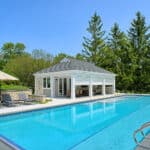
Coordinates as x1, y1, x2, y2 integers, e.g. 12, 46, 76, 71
35, 70, 115, 98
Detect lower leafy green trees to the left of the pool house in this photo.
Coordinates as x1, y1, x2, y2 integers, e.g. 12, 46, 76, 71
0, 42, 67, 89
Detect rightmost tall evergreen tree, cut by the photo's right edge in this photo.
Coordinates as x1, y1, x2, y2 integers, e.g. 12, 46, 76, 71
128, 12, 150, 91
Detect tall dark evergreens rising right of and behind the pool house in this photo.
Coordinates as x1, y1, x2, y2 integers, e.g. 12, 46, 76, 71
78, 12, 150, 93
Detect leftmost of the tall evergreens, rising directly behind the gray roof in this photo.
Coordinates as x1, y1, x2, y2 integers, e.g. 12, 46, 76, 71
82, 13, 105, 64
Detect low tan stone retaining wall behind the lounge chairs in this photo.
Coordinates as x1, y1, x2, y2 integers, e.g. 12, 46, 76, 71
2, 90, 32, 100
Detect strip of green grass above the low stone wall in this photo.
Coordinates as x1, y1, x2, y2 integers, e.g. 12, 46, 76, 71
1, 84, 29, 91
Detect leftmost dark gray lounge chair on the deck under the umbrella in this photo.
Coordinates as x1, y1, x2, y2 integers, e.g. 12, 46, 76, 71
1, 94, 19, 107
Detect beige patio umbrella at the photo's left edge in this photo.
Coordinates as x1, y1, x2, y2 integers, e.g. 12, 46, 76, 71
0, 71, 18, 100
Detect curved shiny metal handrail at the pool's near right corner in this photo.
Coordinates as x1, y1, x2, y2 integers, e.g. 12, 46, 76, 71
133, 122, 150, 148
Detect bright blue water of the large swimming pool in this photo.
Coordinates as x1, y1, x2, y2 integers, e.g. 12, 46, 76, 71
0, 96, 150, 150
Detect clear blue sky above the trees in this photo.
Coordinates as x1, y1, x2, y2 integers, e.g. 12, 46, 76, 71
0, 0, 150, 55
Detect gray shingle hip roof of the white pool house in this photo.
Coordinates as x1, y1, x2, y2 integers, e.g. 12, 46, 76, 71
37, 58, 114, 74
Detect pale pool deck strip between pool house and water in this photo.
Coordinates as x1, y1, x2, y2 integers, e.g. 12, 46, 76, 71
0, 93, 125, 116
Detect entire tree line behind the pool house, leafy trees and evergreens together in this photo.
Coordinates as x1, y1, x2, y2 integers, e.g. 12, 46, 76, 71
0, 12, 150, 93
